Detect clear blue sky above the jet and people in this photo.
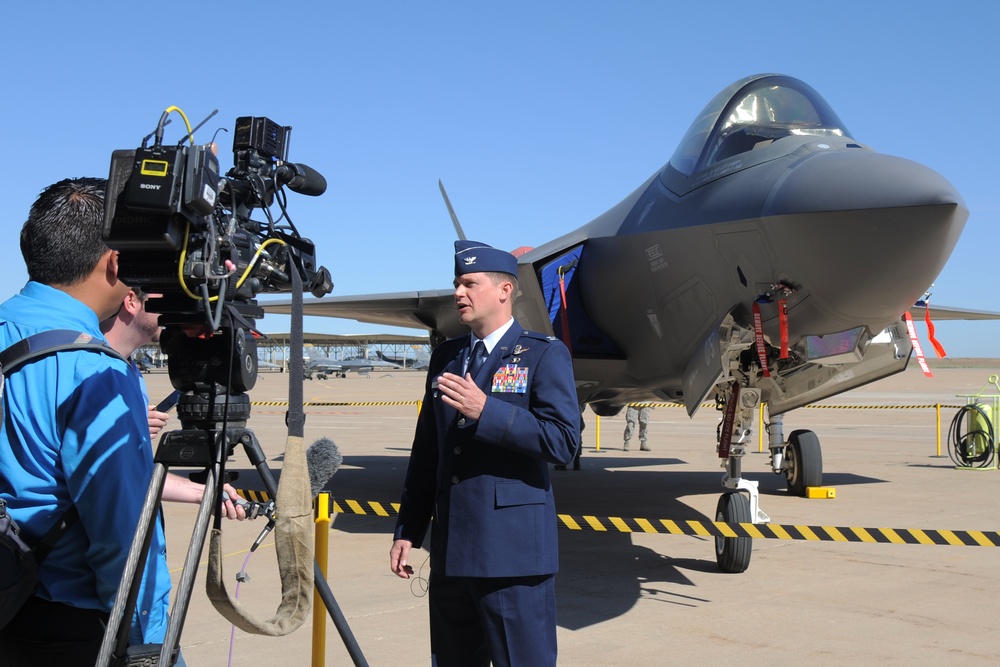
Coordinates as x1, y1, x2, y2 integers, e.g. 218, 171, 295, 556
0, 0, 1000, 357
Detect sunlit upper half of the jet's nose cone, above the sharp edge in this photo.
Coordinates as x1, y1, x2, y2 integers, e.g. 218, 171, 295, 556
765, 148, 965, 215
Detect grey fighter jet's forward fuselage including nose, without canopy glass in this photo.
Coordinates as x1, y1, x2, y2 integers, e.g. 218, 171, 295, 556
519, 77, 968, 412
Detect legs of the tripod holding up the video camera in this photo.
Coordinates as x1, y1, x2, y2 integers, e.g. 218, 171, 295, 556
97, 429, 368, 667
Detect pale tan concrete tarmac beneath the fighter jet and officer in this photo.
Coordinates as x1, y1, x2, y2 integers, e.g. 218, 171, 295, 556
146, 362, 1000, 667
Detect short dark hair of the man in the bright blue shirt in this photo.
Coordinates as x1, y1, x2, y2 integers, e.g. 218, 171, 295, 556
21, 178, 108, 285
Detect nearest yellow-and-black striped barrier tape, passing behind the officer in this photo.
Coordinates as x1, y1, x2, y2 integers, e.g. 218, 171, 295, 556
239, 490, 1000, 547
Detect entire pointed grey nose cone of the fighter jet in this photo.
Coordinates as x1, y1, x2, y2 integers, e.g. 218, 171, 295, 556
765, 149, 968, 331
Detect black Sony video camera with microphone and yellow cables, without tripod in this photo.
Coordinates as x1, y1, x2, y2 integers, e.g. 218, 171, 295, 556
104, 112, 333, 330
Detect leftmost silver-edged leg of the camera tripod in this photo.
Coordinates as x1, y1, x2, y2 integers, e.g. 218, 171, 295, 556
97, 463, 167, 667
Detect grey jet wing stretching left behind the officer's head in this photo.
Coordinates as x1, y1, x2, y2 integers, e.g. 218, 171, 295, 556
261, 289, 458, 340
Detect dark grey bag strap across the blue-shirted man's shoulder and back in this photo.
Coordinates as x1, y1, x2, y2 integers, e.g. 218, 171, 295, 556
0, 329, 128, 563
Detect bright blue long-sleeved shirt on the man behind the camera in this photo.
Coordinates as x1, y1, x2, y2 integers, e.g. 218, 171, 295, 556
0, 282, 170, 643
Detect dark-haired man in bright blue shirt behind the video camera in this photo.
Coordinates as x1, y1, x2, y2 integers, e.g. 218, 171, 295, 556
0, 178, 176, 667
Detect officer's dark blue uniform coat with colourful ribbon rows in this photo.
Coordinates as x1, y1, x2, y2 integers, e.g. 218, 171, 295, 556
395, 320, 580, 577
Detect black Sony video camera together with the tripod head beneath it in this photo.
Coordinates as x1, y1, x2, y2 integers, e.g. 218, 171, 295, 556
103, 115, 333, 412
